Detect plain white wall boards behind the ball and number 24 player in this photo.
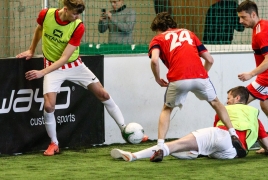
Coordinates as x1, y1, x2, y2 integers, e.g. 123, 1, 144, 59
104, 53, 268, 144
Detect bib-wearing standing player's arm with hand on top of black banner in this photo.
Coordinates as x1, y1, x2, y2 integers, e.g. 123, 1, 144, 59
16, 24, 43, 60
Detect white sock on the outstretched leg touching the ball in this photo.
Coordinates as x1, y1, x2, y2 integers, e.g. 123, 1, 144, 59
102, 96, 126, 131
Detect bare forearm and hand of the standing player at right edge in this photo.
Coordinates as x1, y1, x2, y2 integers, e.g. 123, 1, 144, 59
238, 54, 268, 81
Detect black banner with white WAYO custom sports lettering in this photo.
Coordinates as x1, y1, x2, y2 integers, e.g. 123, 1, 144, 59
0, 55, 104, 154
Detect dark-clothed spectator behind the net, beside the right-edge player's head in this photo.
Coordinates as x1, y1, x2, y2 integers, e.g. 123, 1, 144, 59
203, 0, 245, 44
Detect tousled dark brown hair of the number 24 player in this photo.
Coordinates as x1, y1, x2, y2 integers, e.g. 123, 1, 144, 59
151, 12, 177, 31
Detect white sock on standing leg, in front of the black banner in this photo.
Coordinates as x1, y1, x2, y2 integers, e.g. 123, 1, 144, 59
44, 110, 59, 145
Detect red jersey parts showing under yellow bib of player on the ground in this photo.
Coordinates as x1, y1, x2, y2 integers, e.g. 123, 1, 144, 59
213, 114, 267, 149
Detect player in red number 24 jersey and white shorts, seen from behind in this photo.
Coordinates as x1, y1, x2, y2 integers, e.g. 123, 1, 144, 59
149, 12, 246, 162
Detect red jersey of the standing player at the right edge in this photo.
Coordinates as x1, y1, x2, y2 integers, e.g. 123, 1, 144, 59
252, 20, 268, 86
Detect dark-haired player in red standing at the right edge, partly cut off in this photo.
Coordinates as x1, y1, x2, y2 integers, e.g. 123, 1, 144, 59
237, 0, 268, 152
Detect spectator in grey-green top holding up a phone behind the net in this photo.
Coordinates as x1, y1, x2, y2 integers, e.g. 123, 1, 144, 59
98, 0, 136, 44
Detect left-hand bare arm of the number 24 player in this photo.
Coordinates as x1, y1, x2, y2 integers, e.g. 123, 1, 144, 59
151, 48, 168, 87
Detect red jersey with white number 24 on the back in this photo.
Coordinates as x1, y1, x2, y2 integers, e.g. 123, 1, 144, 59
148, 29, 208, 82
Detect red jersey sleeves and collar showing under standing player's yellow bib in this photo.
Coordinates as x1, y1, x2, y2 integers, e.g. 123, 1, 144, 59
36, 9, 85, 46
